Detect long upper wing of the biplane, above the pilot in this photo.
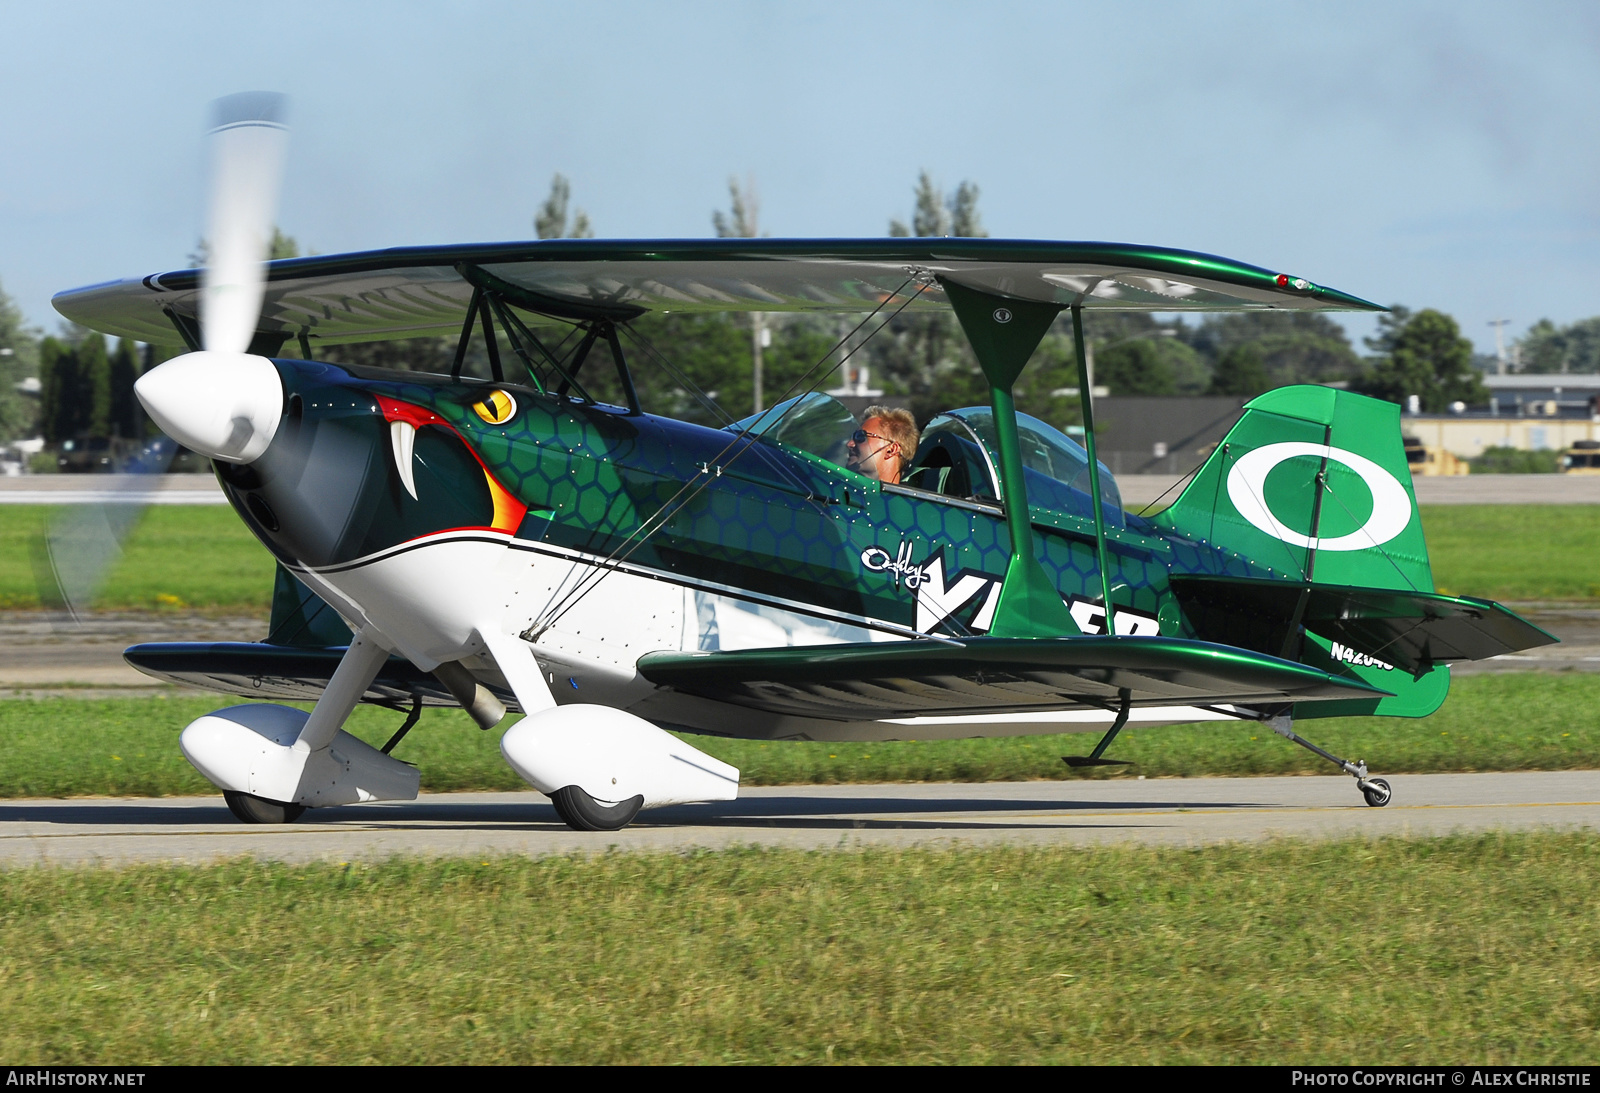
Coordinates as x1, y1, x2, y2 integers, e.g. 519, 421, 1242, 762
54, 238, 1382, 346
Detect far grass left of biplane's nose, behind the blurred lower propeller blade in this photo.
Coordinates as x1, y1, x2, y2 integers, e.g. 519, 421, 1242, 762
0, 504, 272, 616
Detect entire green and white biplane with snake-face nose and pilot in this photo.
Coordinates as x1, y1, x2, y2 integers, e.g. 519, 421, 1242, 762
46, 96, 1554, 831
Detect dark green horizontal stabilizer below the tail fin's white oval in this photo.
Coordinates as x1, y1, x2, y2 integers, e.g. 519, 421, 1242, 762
1171, 575, 1557, 675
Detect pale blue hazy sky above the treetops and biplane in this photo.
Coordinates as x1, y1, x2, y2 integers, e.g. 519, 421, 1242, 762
0, 0, 1600, 349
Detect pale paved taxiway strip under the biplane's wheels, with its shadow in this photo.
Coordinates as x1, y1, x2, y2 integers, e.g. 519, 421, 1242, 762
0, 771, 1600, 867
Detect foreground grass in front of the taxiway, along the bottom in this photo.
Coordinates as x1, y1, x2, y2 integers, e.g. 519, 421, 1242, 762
0, 832, 1600, 1066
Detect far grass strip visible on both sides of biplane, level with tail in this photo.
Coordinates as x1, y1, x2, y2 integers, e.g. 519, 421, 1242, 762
0, 504, 1600, 615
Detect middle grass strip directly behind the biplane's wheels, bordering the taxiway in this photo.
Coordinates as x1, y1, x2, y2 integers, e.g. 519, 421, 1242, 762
0, 672, 1600, 797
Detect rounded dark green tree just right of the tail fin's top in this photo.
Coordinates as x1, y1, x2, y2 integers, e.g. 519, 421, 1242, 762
1352, 307, 1490, 413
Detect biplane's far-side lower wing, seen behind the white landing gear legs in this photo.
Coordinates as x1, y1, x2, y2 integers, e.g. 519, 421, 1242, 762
122, 642, 522, 712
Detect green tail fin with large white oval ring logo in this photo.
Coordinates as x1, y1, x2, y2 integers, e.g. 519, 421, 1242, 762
1154, 386, 1434, 592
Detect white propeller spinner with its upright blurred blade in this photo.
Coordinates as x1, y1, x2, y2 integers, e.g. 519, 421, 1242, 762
134, 91, 288, 462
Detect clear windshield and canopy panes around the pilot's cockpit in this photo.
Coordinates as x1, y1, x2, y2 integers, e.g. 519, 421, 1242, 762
728, 392, 1125, 528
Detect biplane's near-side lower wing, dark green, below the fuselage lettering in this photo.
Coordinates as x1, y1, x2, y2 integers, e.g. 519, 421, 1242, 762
638, 637, 1387, 720
